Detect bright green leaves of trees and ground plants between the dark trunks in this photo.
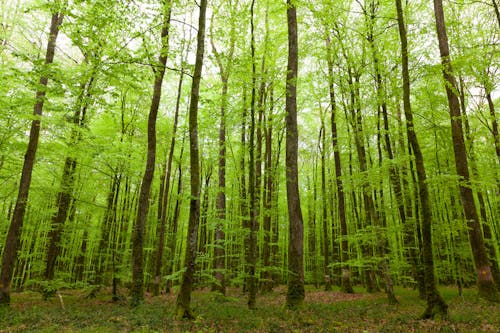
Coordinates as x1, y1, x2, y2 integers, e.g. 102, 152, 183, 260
0, 0, 500, 320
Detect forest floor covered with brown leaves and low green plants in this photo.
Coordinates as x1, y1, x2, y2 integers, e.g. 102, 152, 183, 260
0, 287, 500, 333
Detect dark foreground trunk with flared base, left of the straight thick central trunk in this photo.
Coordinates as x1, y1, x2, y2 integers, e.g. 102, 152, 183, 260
176, 0, 207, 319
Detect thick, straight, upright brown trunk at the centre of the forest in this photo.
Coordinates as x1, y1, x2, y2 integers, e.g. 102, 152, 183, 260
285, 0, 305, 309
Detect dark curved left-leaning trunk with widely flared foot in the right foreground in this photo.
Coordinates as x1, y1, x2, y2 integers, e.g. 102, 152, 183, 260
396, 0, 448, 318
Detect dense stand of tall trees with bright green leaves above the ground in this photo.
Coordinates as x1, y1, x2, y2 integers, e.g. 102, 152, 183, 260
0, 0, 500, 326
